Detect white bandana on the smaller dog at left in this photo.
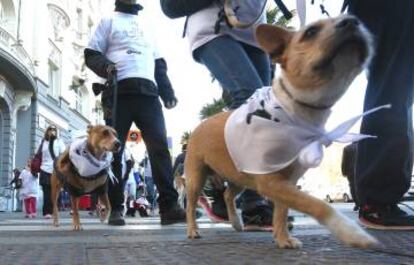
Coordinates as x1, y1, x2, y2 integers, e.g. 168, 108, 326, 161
69, 138, 114, 181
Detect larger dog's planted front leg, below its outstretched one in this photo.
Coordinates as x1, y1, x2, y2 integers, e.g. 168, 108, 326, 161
273, 202, 302, 249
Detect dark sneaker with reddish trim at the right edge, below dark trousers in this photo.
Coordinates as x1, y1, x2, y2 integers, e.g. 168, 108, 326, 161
359, 205, 414, 230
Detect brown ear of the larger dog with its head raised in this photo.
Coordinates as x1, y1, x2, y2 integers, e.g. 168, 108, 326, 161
256, 24, 293, 63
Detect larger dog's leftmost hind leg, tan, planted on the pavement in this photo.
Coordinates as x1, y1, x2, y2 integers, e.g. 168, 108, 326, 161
184, 156, 207, 238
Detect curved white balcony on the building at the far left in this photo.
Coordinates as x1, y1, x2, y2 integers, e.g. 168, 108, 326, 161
0, 26, 34, 75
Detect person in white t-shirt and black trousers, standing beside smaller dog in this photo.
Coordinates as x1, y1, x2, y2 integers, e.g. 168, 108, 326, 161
84, 0, 185, 225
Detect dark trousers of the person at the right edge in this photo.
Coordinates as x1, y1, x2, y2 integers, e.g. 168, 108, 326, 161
350, 0, 414, 206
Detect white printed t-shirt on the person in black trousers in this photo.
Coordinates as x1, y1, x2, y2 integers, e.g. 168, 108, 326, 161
88, 12, 162, 83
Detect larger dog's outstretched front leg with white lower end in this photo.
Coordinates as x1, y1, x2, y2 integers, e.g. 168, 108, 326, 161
257, 175, 378, 248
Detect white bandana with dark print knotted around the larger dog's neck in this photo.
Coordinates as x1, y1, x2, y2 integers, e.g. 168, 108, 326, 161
224, 87, 391, 174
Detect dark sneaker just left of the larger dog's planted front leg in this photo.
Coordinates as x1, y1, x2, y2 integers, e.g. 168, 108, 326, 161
242, 205, 273, 231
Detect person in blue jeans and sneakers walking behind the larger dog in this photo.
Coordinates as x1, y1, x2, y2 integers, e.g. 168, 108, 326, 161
160, 0, 273, 230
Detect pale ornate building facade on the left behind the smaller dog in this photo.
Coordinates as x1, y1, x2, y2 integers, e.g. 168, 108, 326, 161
0, 0, 105, 186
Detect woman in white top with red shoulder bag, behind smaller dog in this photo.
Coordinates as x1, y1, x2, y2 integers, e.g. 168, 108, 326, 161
39, 125, 66, 219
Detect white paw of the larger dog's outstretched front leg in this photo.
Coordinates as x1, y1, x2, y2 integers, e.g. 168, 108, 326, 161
327, 210, 379, 248
